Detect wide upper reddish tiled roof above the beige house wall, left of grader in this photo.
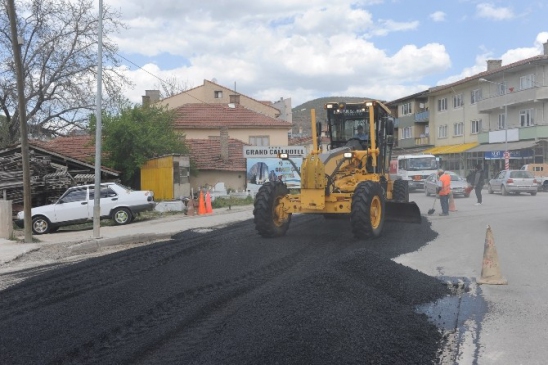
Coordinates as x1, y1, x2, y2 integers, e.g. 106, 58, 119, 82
175, 103, 291, 130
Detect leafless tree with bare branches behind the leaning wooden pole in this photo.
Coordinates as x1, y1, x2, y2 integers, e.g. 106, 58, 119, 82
0, 0, 129, 147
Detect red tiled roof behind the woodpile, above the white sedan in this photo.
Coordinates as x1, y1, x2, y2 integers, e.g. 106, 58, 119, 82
29, 135, 95, 164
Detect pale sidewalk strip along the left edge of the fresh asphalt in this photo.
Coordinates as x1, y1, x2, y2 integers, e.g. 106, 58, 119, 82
0, 205, 253, 266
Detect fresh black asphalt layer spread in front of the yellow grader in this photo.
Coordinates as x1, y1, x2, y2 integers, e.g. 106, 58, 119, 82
0, 215, 454, 365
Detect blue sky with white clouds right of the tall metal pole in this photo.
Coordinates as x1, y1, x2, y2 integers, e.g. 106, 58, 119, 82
108, 0, 548, 107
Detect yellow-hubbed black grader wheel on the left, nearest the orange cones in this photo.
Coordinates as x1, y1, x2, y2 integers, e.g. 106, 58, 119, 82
253, 181, 291, 238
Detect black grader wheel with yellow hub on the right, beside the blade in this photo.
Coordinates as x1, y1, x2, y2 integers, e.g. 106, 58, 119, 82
350, 181, 385, 238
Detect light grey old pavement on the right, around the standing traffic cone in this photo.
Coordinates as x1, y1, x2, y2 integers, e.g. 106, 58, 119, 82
396, 190, 548, 365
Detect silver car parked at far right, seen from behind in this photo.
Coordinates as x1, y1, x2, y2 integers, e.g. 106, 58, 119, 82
487, 170, 538, 195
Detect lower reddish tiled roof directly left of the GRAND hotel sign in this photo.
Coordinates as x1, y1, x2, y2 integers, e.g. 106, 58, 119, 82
185, 138, 247, 172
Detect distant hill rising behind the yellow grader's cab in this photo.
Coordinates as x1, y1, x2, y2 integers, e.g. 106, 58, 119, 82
292, 96, 368, 137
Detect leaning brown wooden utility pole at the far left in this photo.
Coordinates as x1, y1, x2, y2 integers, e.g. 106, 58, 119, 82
7, 0, 32, 243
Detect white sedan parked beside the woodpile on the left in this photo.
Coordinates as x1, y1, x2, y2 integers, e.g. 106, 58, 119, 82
15, 183, 155, 235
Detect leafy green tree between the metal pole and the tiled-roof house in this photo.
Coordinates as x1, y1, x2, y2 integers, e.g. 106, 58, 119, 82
90, 106, 188, 186
